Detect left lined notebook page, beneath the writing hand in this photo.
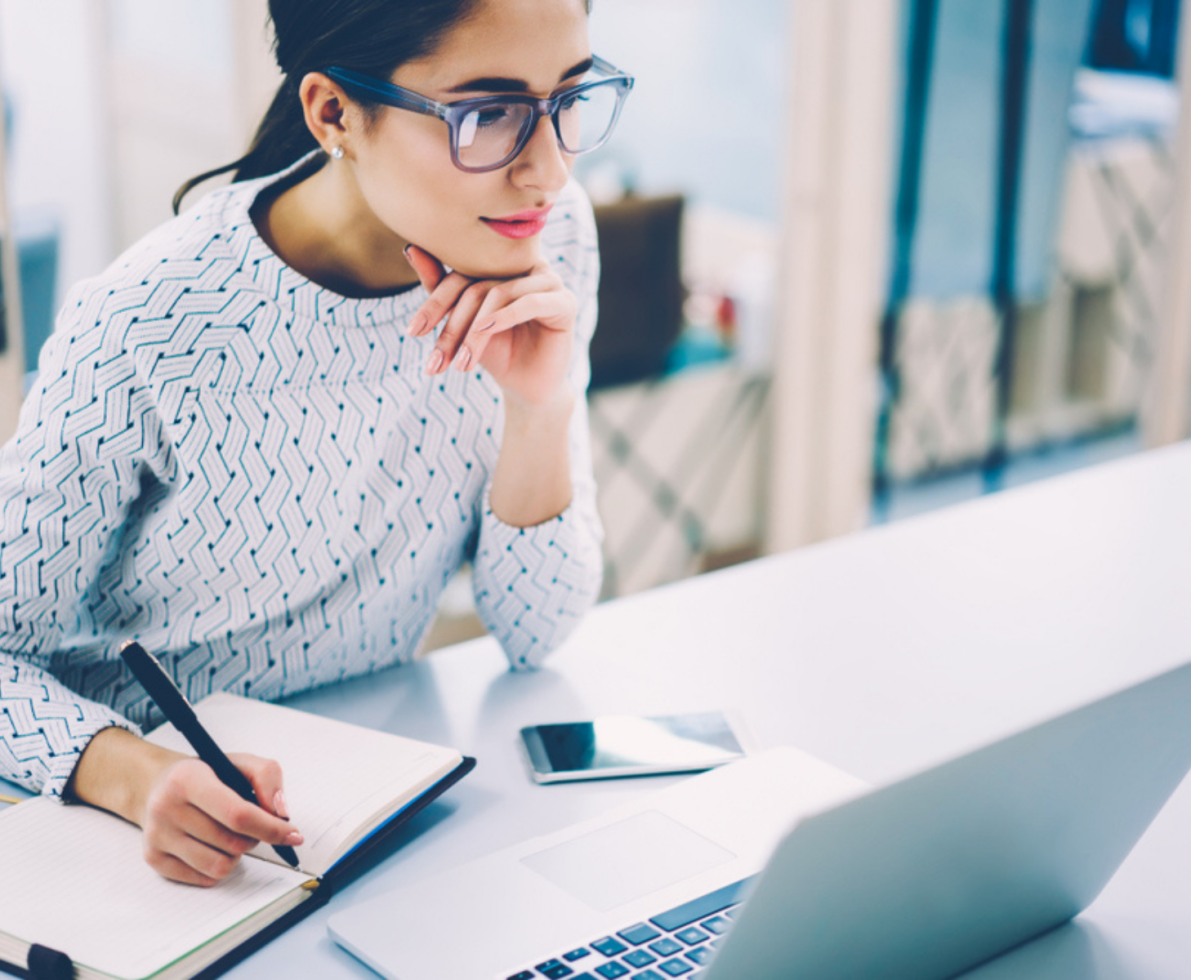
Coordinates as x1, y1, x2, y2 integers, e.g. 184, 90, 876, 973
0, 799, 307, 978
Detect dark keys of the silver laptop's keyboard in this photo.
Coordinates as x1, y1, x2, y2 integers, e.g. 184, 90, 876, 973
509, 878, 753, 980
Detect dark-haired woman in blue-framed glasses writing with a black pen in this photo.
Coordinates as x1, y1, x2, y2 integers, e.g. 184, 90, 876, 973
0, 0, 631, 885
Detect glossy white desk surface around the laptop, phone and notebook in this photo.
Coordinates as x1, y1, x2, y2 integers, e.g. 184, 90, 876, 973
9, 444, 1191, 980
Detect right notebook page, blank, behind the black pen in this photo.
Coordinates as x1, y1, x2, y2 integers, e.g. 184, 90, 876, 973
149, 694, 462, 875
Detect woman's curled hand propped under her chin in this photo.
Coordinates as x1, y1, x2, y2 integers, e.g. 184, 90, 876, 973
406, 245, 579, 406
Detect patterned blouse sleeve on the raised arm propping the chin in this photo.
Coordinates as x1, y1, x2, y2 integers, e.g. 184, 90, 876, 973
473, 183, 604, 669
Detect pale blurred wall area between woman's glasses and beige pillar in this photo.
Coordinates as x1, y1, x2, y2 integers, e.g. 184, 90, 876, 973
576, 0, 793, 227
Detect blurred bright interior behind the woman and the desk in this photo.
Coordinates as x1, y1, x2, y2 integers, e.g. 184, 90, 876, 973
0, 0, 1191, 645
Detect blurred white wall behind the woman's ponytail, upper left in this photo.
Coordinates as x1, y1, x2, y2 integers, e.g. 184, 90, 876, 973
0, 0, 275, 301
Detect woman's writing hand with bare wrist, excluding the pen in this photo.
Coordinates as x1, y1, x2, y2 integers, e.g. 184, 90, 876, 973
73, 728, 303, 885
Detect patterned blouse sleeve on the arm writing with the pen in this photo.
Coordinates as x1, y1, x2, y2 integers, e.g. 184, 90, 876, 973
0, 285, 146, 799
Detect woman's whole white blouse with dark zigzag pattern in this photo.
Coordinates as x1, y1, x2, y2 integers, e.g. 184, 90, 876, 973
0, 160, 601, 798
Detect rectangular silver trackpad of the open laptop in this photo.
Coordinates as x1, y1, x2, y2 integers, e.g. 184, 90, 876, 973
522, 810, 736, 912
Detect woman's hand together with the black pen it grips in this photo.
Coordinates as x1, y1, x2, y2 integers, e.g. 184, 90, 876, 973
117, 643, 303, 885
